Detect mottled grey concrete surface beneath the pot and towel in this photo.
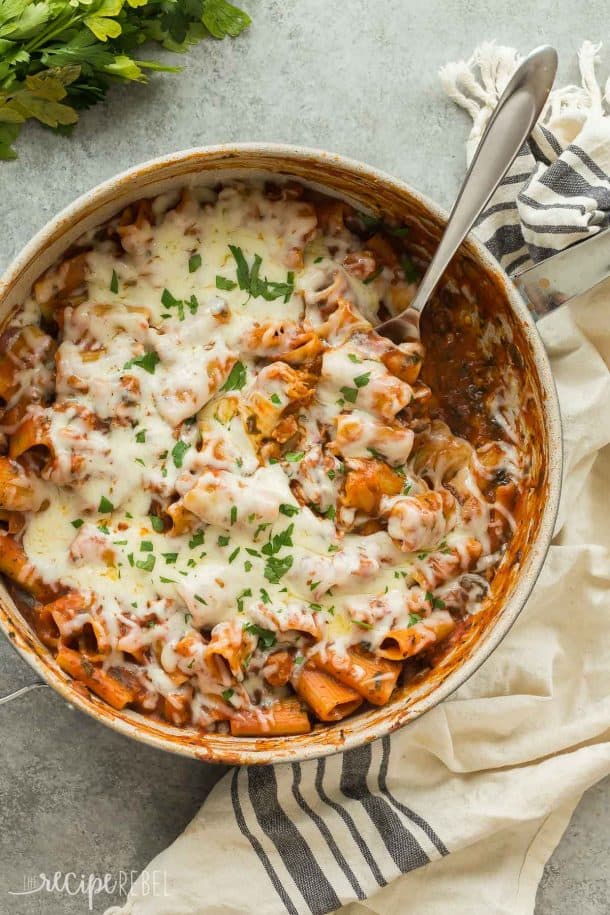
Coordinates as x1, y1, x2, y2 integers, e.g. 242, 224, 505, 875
0, 0, 610, 915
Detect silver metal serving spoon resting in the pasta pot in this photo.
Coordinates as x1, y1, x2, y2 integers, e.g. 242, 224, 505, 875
375, 45, 557, 343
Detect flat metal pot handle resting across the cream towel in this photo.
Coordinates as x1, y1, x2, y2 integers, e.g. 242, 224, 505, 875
513, 228, 610, 321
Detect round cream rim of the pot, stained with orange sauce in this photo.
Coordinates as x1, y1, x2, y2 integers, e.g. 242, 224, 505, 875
0, 142, 562, 764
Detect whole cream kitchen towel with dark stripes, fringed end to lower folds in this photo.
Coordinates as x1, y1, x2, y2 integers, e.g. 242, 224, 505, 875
107, 43, 610, 915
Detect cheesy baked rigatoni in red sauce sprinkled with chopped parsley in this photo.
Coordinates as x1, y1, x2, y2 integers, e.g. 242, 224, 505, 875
0, 180, 527, 736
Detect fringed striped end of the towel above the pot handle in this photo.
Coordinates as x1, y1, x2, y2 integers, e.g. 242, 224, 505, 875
440, 41, 610, 273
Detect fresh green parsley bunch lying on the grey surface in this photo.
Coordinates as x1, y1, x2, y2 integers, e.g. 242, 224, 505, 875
0, 0, 250, 159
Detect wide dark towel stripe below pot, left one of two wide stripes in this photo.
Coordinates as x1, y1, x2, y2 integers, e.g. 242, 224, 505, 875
248, 766, 341, 912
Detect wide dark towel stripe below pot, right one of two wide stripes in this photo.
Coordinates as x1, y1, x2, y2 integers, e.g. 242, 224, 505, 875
341, 745, 430, 874
